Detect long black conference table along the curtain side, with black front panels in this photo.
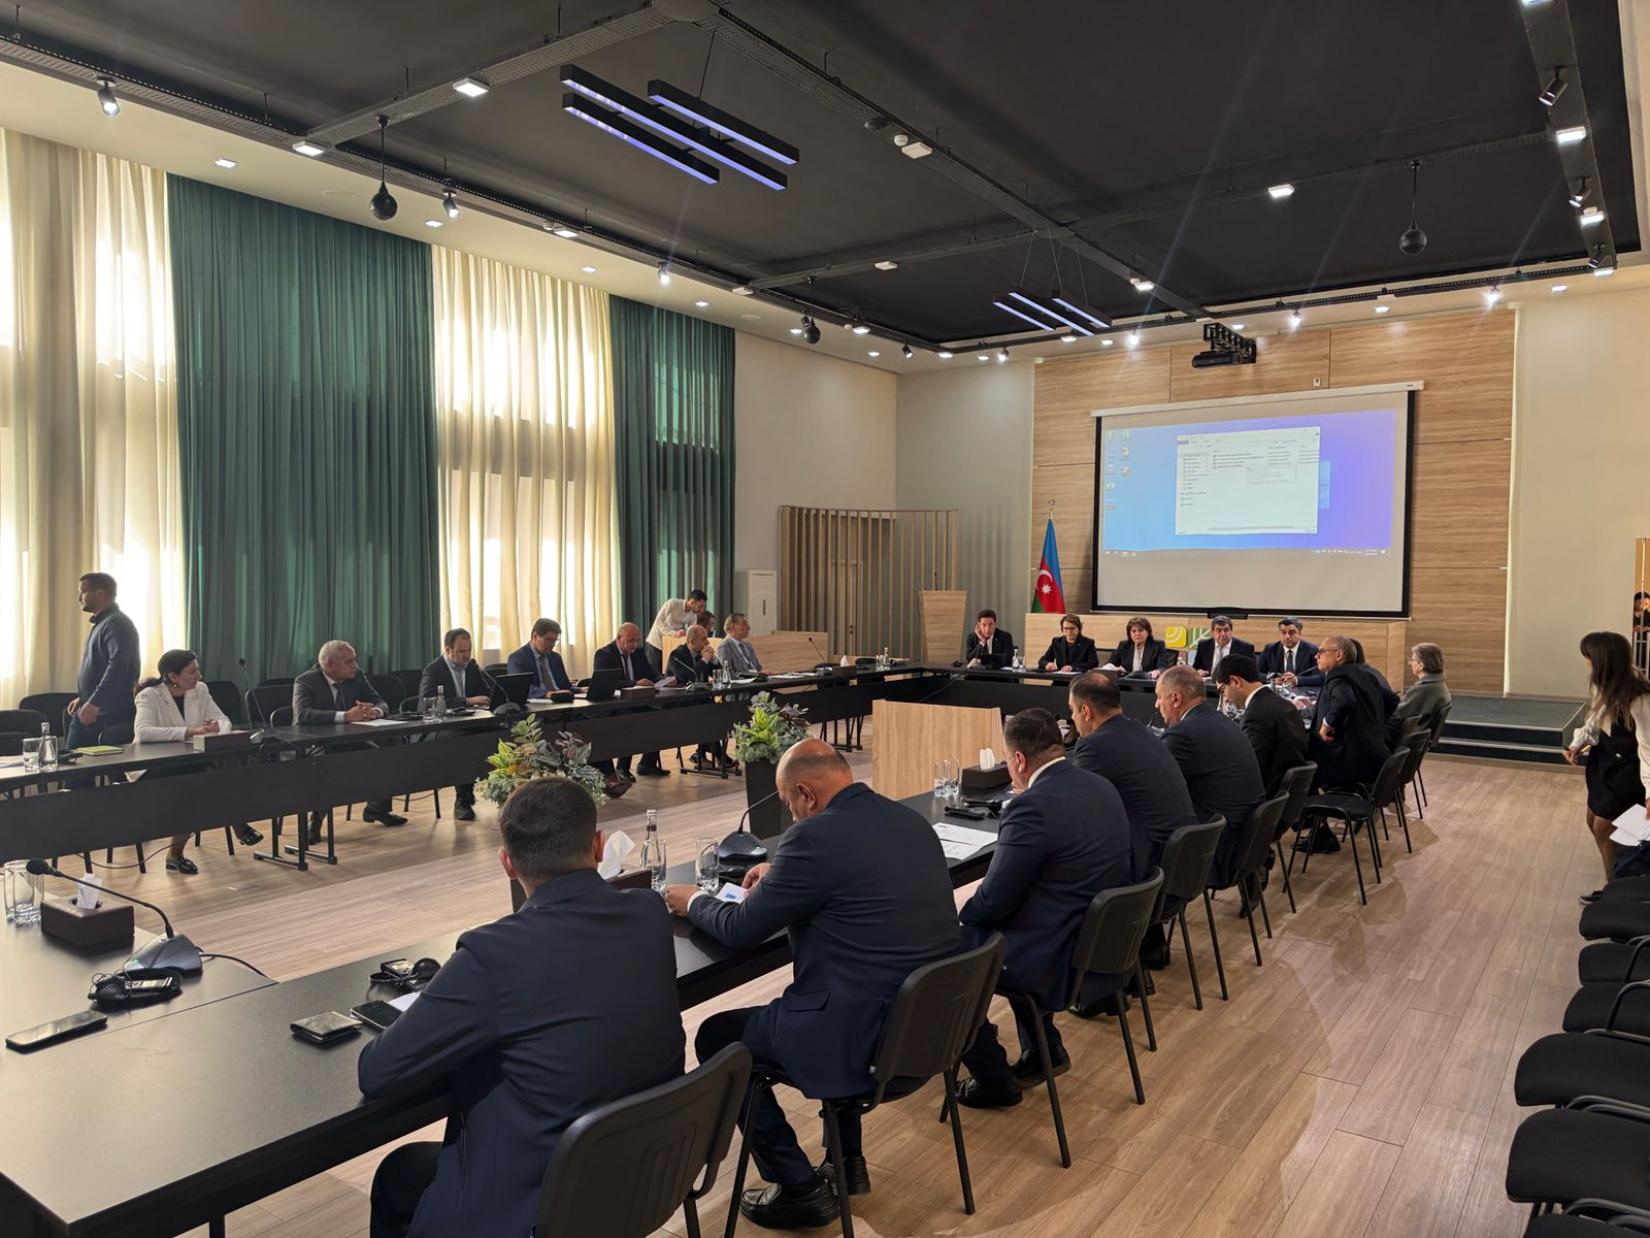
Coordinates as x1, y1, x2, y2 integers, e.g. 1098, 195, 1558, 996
0, 664, 1188, 868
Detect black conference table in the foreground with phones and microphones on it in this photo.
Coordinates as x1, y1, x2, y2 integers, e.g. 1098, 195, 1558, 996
0, 796, 997, 1238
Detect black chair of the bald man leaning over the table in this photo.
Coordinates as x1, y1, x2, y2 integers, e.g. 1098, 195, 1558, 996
726, 933, 1003, 1238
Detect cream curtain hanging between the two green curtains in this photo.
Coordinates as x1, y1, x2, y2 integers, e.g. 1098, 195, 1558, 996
431, 246, 619, 675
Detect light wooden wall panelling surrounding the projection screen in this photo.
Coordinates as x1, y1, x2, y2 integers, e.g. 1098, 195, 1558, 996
1028, 309, 1516, 693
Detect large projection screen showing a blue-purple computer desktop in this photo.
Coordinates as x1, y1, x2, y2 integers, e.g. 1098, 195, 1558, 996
1089, 381, 1424, 619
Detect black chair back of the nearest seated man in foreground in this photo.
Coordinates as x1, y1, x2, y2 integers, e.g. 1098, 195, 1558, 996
533, 1043, 751, 1238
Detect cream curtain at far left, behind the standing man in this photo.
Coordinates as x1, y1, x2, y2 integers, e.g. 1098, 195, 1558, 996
0, 132, 185, 708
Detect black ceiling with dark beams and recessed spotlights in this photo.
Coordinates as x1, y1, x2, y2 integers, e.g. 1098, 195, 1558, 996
0, 0, 1640, 348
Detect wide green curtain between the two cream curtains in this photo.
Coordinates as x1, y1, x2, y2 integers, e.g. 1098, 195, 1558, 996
167, 177, 441, 682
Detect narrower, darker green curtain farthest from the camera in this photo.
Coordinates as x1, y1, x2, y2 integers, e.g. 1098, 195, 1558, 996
609, 297, 734, 632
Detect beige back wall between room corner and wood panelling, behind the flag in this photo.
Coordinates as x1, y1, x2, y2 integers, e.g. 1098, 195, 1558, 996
894, 361, 1036, 631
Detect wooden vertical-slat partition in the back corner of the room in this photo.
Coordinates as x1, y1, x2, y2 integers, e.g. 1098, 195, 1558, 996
779, 507, 957, 657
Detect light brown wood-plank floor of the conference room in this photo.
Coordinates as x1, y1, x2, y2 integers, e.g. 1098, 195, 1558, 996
58, 756, 1599, 1238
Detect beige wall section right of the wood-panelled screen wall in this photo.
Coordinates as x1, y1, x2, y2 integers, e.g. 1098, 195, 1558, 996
1508, 289, 1650, 697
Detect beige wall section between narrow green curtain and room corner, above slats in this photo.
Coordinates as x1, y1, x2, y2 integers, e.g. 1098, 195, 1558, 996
733, 332, 898, 588
